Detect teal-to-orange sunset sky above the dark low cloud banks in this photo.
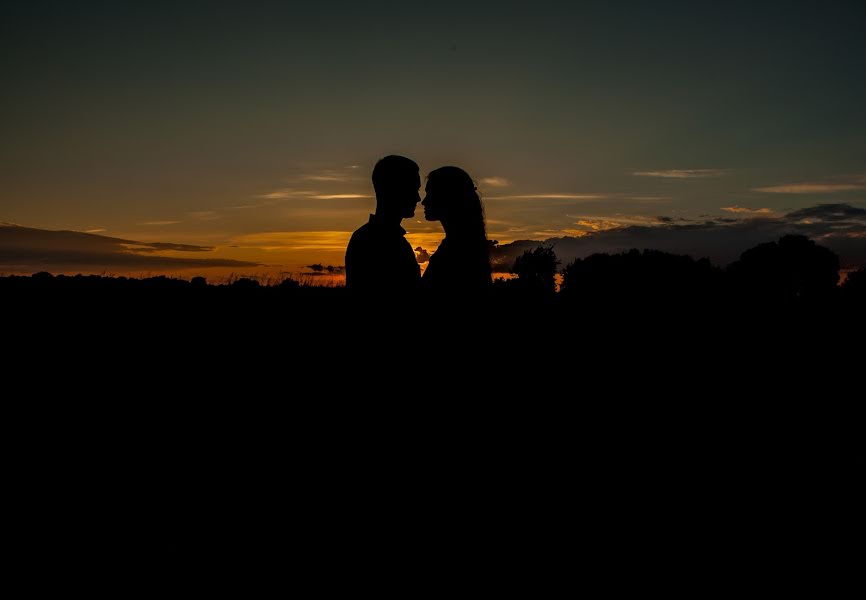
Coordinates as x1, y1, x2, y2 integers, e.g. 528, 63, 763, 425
0, 0, 866, 270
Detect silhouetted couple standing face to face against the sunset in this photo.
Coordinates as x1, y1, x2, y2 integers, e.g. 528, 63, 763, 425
346, 156, 491, 300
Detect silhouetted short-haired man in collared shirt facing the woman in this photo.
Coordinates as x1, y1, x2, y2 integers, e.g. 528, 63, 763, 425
346, 155, 421, 296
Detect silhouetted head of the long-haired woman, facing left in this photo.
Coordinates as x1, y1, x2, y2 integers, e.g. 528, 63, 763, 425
421, 167, 484, 234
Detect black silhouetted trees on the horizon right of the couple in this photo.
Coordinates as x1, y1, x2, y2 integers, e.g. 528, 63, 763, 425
500, 236, 866, 312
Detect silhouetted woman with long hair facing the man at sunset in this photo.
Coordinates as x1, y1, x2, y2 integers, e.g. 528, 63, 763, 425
421, 167, 491, 297
